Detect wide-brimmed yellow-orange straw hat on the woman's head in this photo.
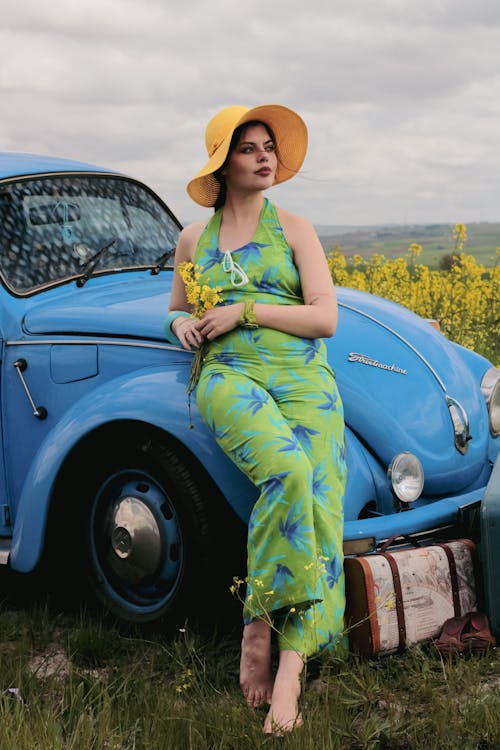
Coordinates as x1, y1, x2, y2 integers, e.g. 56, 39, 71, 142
187, 104, 307, 207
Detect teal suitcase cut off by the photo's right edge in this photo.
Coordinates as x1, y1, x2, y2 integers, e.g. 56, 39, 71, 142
480, 457, 500, 640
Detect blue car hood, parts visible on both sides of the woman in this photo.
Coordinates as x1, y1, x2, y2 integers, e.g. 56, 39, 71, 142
23, 272, 488, 495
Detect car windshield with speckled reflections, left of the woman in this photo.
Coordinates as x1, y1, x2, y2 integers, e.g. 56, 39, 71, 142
0, 174, 180, 292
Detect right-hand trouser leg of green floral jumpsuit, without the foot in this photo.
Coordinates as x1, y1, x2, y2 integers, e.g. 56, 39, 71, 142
270, 366, 345, 656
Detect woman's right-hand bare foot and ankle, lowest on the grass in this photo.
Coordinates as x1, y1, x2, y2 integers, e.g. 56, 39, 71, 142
264, 650, 304, 735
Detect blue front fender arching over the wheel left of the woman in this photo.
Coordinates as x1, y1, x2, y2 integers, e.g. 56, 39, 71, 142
10, 366, 255, 572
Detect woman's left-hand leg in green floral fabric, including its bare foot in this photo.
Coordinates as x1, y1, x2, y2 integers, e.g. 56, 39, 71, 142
197, 365, 316, 705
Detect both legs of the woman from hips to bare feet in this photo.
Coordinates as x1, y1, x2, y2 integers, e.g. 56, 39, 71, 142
197, 366, 345, 731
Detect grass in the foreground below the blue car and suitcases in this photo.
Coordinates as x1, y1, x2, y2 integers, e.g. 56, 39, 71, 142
0, 602, 500, 750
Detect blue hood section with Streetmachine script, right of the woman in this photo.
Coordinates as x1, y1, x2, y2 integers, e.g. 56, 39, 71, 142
327, 289, 489, 495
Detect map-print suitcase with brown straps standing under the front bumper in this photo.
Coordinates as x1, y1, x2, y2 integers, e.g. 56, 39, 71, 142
345, 539, 477, 656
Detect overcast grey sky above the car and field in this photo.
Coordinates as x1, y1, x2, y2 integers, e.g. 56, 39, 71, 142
0, 0, 500, 224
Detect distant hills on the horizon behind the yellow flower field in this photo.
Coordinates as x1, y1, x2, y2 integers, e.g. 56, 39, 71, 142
316, 222, 500, 266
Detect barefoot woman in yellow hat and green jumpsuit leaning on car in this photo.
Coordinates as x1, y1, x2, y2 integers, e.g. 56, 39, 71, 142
166, 105, 345, 733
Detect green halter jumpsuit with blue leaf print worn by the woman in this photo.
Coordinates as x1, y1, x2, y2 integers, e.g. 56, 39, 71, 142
195, 199, 345, 656
